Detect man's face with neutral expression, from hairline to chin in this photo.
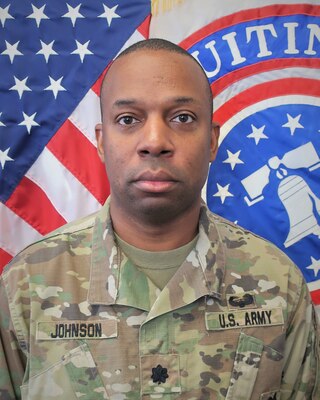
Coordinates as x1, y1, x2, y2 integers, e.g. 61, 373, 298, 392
96, 50, 217, 223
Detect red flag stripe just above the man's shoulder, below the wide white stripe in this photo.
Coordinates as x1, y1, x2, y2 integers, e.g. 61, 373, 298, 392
5, 177, 66, 235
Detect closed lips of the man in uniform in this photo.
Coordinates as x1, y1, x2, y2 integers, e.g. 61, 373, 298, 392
133, 171, 178, 193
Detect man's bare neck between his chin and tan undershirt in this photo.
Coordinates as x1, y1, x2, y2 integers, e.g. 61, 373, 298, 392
110, 203, 200, 251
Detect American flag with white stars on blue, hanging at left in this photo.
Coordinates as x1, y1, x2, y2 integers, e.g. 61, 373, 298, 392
0, 0, 150, 271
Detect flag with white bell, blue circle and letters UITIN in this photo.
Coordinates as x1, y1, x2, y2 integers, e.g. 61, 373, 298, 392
150, 0, 320, 312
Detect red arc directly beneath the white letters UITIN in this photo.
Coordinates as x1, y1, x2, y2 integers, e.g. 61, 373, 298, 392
211, 58, 320, 96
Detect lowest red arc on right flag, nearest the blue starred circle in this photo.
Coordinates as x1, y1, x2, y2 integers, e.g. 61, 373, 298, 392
214, 78, 320, 125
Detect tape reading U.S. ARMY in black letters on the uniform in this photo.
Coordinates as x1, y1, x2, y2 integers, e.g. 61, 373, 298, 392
205, 307, 284, 331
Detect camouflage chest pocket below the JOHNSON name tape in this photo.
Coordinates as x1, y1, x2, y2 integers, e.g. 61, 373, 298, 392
21, 344, 108, 400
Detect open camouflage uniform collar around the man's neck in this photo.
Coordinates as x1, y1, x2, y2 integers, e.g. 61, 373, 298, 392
88, 199, 225, 319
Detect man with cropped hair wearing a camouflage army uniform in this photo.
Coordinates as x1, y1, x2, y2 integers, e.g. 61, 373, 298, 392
0, 40, 320, 400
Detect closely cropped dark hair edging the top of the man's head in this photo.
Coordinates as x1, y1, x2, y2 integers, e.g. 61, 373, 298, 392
101, 38, 213, 114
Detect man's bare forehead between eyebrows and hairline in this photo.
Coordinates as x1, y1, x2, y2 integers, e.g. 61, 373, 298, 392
101, 48, 212, 113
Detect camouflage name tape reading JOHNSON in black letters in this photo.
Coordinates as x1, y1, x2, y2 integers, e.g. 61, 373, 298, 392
36, 320, 118, 340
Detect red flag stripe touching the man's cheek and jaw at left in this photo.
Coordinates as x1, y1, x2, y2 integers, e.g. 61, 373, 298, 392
47, 120, 110, 204
